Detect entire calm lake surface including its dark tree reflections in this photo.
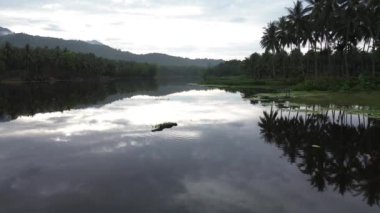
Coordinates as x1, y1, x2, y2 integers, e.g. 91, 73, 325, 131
0, 81, 380, 213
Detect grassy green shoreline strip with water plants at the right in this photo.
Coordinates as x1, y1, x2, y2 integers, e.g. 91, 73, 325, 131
200, 77, 380, 118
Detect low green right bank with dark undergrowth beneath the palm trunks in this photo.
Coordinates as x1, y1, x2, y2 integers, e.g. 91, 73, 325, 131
203, 76, 380, 118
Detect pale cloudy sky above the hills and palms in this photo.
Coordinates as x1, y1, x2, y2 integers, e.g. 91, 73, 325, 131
0, 0, 293, 60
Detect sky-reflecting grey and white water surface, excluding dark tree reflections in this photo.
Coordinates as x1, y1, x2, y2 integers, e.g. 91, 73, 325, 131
0, 83, 378, 213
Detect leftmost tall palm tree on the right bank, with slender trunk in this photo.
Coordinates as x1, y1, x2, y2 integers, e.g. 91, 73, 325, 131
260, 22, 280, 77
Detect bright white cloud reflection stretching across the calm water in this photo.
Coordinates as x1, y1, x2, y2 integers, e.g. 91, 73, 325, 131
0, 90, 261, 142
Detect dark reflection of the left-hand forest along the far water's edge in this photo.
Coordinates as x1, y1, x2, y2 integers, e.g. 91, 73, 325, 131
0, 81, 157, 122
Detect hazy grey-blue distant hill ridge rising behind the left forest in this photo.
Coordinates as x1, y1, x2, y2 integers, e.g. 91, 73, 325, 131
0, 33, 223, 67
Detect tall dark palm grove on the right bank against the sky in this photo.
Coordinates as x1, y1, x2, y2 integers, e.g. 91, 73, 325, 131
206, 0, 380, 79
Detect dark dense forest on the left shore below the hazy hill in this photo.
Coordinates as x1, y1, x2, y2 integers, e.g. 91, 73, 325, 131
0, 43, 157, 81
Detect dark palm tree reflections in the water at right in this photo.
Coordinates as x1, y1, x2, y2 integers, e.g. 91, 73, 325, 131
259, 108, 380, 206
